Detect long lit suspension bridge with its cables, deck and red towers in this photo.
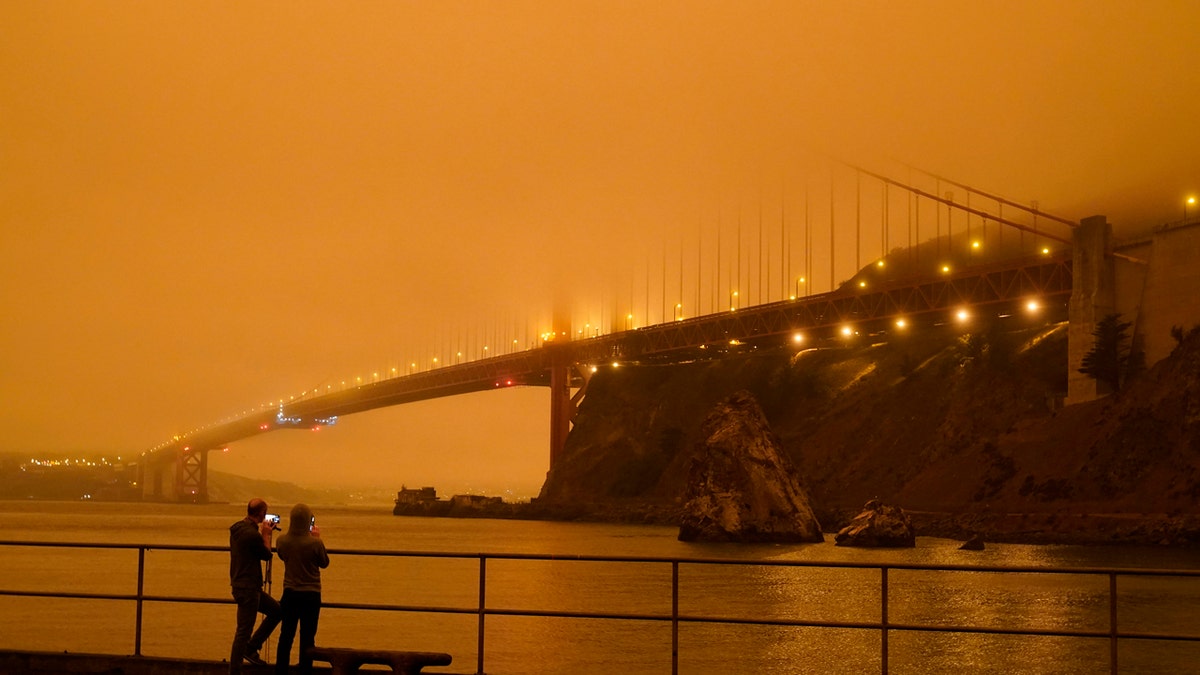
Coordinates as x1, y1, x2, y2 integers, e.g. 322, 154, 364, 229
139, 167, 1078, 501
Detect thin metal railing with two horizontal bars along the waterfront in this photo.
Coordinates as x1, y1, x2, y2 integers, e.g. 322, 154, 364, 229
0, 540, 1200, 674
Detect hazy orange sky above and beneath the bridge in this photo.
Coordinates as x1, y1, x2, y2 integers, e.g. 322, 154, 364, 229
0, 0, 1200, 492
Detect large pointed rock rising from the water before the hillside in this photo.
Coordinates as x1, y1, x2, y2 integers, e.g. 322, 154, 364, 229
679, 390, 824, 543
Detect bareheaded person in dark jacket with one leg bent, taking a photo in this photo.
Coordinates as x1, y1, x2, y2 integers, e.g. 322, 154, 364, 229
229, 497, 281, 675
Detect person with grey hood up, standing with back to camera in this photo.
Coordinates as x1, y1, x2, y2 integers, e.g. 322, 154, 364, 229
275, 503, 329, 675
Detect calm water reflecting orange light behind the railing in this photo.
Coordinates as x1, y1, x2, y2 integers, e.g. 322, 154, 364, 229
0, 502, 1200, 675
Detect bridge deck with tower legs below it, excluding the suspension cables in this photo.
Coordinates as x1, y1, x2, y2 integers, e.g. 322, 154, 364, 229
142, 247, 1072, 501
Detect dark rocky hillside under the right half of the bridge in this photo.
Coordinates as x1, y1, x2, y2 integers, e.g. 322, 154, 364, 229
539, 317, 1200, 543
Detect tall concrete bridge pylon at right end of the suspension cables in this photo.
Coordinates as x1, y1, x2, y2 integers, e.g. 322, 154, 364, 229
1067, 216, 1116, 404
